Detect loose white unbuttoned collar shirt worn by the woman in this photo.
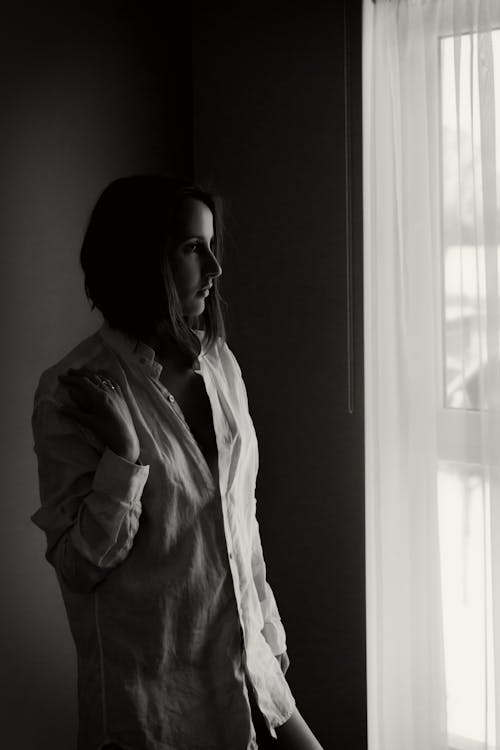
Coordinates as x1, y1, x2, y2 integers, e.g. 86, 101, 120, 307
32, 323, 295, 750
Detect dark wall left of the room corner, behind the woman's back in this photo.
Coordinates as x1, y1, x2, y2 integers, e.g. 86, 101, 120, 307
0, 0, 192, 750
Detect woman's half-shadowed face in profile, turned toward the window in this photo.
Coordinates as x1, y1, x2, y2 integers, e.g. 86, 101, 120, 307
169, 198, 222, 316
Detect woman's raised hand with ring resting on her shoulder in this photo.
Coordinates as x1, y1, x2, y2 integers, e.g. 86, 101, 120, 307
59, 367, 140, 463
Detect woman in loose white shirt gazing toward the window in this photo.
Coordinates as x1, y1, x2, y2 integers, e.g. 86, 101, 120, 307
32, 176, 320, 750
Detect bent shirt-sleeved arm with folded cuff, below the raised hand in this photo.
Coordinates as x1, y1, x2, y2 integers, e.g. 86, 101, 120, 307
31, 398, 149, 592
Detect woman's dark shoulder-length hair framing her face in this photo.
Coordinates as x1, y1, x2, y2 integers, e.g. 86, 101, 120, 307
80, 175, 226, 359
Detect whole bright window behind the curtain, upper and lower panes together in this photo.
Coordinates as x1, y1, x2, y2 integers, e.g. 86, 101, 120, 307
438, 30, 500, 750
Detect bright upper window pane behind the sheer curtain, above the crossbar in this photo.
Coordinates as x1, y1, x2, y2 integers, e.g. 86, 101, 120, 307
440, 29, 500, 409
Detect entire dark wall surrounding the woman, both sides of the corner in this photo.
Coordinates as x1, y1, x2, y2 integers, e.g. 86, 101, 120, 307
0, 0, 366, 750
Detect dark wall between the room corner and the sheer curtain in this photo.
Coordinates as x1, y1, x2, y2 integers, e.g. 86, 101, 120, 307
193, 0, 366, 750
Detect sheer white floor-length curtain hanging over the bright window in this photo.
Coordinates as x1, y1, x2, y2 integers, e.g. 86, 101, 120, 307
363, 0, 500, 750
